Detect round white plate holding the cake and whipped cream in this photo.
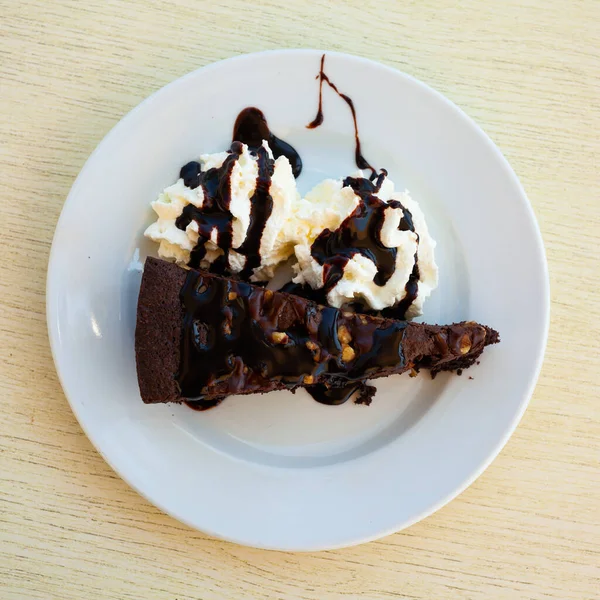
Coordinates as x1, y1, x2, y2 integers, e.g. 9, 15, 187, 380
47, 50, 549, 550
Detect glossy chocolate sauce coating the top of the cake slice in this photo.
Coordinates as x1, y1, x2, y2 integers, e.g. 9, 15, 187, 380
177, 270, 406, 409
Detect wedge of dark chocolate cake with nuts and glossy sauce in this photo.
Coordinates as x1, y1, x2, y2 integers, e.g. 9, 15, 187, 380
135, 258, 499, 406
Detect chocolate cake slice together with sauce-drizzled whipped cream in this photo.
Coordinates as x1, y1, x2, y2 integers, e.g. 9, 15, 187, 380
135, 95, 499, 409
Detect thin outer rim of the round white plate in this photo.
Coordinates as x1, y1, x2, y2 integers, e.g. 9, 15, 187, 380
46, 49, 550, 552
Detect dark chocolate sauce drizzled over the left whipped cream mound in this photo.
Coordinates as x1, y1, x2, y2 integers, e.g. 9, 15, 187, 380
175, 107, 302, 279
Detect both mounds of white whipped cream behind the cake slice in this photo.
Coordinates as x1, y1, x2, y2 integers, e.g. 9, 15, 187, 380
145, 150, 438, 318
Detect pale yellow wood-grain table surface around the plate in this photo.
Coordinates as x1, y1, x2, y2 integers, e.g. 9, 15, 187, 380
0, 0, 600, 600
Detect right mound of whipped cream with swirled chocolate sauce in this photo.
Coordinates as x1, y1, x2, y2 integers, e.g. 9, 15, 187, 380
294, 172, 438, 318
